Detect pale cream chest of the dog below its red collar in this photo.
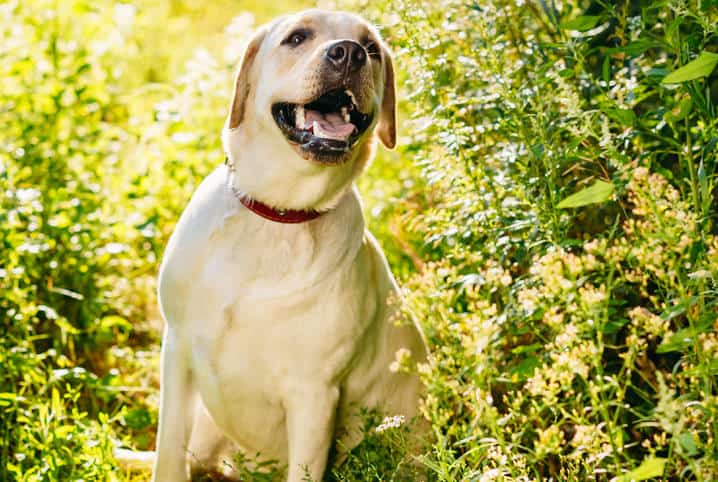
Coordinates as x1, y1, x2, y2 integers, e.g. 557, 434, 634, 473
180, 209, 374, 449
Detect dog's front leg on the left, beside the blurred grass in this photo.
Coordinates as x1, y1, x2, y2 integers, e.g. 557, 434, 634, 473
152, 326, 194, 482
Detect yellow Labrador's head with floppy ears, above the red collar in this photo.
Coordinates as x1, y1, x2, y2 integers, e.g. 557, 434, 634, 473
224, 10, 396, 209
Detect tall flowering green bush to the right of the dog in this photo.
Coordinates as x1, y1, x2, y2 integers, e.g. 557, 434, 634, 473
360, 0, 718, 480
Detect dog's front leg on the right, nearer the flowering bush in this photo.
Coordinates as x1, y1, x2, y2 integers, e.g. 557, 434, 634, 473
285, 386, 339, 482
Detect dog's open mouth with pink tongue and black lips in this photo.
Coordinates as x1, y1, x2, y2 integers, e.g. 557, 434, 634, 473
272, 90, 372, 159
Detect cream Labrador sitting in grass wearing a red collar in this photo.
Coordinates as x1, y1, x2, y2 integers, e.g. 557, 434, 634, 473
153, 10, 427, 482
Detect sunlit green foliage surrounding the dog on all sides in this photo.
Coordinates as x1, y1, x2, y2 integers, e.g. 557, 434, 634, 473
0, 0, 718, 481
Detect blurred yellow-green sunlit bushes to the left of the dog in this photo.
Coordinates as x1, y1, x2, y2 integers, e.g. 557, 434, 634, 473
0, 0, 252, 480
